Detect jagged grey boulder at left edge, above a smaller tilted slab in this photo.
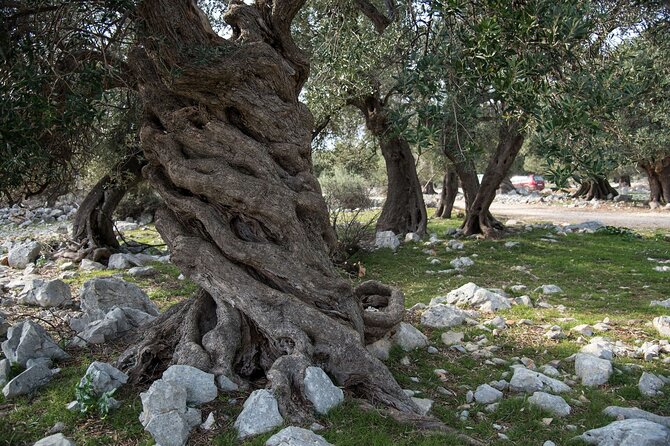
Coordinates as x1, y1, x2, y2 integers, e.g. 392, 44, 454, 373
2, 321, 69, 367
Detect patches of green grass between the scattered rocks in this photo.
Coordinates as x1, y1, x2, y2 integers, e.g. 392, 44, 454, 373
0, 215, 670, 445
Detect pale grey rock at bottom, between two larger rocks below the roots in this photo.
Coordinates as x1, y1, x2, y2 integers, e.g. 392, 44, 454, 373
234, 389, 284, 439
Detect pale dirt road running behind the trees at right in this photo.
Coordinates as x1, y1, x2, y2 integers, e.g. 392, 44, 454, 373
456, 201, 670, 229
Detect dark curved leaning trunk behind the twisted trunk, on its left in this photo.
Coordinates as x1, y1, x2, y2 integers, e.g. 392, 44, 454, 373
72, 155, 145, 260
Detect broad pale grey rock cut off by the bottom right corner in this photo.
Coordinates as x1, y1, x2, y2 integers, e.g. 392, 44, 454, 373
577, 419, 670, 446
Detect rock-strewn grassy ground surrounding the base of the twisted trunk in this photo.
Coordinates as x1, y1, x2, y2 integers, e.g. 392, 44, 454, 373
0, 196, 670, 446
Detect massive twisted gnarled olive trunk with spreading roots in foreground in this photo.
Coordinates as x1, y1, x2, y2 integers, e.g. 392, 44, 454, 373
119, 0, 417, 422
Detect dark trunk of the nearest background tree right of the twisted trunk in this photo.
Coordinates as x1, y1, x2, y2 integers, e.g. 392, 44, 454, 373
352, 95, 428, 235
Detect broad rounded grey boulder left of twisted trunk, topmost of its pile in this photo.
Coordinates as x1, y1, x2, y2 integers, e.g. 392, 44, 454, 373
79, 277, 158, 319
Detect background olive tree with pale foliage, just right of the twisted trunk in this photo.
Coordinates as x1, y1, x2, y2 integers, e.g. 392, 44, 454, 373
301, 0, 427, 234
